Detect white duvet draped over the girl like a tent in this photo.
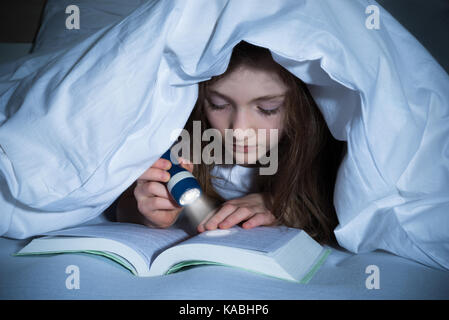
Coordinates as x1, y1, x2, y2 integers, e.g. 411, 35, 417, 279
0, 0, 449, 268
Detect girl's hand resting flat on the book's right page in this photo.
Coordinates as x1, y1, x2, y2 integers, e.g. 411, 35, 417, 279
197, 193, 276, 232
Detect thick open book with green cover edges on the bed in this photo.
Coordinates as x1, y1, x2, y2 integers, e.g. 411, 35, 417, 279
16, 222, 330, 283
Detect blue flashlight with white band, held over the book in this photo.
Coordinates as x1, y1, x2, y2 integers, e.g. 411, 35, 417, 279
162, 149, 201, 207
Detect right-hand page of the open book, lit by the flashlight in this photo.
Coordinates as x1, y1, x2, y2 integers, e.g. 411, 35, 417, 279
183, 226, 302, 253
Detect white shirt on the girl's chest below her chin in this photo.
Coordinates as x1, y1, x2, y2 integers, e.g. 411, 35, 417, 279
211, 165, 259, 200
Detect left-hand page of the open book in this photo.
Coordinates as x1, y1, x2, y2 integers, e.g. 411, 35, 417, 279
45, 222, 189, 264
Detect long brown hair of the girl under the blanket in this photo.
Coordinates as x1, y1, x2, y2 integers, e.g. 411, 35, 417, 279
180, 41, 344, 243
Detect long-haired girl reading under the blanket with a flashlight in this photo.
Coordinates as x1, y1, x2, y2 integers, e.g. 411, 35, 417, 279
117, 41, 344, 243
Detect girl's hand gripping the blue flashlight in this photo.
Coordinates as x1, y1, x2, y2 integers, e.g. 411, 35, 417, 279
134, 158, 193, 228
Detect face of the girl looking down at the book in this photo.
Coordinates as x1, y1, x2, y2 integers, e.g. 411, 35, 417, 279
204, 65, 287, 164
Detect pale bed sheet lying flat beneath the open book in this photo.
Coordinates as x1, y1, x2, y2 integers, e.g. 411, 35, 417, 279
0, 230, 449, 300
